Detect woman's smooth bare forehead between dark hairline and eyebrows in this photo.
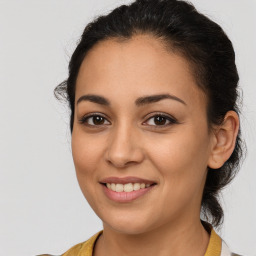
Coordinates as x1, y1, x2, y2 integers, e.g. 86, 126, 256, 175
76, 35, 205, 107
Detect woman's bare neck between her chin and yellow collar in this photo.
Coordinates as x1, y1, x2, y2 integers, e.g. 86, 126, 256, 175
94, 220, 209, 256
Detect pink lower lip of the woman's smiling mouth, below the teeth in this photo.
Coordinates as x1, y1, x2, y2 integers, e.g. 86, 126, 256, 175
102, 185, 154, 203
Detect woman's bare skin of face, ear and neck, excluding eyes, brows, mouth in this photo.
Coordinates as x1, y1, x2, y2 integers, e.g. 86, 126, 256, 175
72, 35, 239, 256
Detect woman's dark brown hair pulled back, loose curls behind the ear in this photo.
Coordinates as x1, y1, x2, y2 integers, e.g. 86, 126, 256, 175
55, 0, 242, 226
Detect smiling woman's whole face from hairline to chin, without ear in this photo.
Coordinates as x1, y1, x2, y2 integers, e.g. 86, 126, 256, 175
72, 35, 213, 234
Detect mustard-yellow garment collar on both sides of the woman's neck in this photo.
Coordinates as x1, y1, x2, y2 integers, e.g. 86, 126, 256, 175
61, 229, 222, 256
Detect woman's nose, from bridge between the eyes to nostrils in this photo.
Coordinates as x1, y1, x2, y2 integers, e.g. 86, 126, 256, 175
106, 125, 144, 168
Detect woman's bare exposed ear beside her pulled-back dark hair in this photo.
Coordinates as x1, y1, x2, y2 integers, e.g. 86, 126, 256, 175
208, 111, 239, 169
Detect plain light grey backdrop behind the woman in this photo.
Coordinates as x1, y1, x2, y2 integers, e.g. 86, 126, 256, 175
0, 0, 256, 256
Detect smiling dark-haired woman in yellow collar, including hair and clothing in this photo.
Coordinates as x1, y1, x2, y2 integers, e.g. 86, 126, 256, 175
49, 0, 242, 256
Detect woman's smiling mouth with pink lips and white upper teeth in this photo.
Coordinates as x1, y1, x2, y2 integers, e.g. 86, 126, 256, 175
100, 177, 157, 202
